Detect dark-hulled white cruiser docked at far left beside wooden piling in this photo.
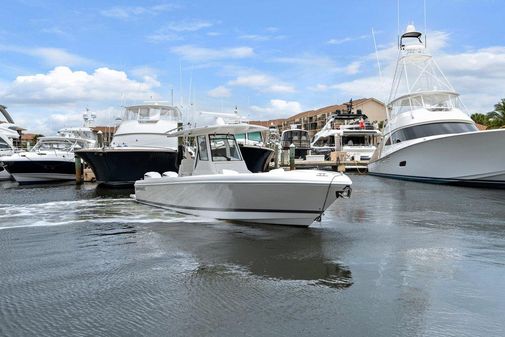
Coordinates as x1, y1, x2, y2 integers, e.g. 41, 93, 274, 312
0, 115, 96, 184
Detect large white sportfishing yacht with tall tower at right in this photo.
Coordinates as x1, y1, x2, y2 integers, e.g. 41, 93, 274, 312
368, 25, 505, 188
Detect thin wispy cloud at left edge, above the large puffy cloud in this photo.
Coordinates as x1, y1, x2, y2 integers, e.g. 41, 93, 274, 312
0, 45, 94, 66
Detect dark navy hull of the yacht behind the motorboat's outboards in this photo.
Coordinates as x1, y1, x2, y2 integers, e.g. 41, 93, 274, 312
75, 148, 177, 187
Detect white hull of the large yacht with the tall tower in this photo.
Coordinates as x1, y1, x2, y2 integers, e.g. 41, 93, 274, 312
368, 130, 505, 188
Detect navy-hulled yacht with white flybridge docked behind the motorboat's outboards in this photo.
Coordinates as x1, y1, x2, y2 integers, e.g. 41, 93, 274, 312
76, 102, 181, 187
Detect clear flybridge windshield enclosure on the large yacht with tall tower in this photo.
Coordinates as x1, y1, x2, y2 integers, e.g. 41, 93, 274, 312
390, 92, 463, 116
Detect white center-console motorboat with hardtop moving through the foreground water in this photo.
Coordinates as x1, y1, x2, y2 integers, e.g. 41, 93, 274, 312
135, 124, 352, 227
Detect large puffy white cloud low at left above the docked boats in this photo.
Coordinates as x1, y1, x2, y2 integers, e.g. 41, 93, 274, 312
0, 66, 160, 104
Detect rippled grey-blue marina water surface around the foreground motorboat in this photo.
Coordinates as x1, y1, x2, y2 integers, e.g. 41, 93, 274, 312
0, 176, 505, 336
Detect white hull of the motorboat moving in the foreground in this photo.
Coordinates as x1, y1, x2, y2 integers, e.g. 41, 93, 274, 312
135, 171, 351, 227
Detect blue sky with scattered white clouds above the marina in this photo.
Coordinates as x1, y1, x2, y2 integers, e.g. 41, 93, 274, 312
0, 0, 505, 135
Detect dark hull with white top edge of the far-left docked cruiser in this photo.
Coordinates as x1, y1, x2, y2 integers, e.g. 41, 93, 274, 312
2, 157, 75, 184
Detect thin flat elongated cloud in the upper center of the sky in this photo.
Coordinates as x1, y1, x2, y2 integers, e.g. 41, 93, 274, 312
171, 45, 254, 61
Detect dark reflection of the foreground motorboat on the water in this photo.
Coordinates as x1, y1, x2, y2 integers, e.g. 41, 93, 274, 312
152, 223, 353, 288
